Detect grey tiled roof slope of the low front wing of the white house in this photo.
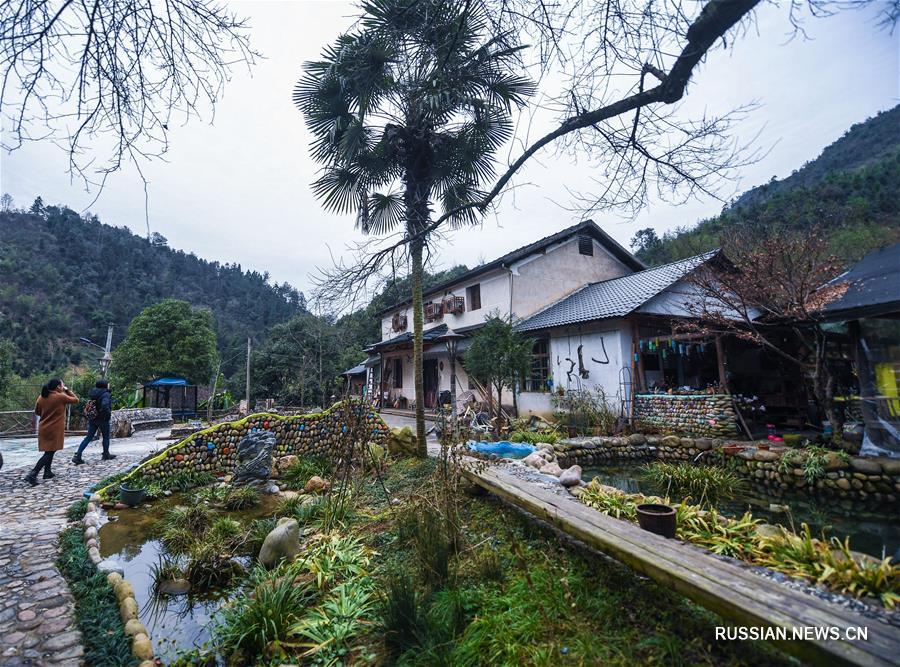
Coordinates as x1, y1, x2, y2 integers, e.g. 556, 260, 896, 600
516, 250, 719, 331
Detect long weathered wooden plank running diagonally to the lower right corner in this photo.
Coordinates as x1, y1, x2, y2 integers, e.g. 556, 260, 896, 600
463, 467, 900, 665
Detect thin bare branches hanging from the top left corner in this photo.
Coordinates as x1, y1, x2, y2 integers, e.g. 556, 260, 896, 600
0, 0, 257, 192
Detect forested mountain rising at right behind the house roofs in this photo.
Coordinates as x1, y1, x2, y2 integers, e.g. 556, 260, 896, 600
632, 106, 900, 265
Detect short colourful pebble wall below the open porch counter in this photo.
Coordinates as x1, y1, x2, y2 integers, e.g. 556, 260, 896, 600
634, 394, 738, 438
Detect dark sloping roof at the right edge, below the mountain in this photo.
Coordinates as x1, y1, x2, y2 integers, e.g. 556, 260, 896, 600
823, 243, 900, 320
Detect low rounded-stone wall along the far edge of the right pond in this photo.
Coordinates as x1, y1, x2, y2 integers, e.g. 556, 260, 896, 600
553, 433, 900, 506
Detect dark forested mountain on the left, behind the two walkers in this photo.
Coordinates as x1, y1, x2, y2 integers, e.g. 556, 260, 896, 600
0, 200, 305, 376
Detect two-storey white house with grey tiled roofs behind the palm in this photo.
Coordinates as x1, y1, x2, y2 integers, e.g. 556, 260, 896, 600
367, 220, 719, 415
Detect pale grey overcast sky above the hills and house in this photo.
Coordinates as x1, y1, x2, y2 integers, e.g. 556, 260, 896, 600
0, 1, 900, 304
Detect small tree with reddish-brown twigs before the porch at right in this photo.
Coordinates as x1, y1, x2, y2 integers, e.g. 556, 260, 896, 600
676, 225, 847, 434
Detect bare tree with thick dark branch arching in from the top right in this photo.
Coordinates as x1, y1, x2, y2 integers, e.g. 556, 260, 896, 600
318, 0, 900, 314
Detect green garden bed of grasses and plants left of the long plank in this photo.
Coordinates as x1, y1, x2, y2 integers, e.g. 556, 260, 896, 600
82, 452, 796, 665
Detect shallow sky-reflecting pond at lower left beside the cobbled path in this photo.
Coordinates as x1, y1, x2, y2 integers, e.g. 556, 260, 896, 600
100, 494, 278, 664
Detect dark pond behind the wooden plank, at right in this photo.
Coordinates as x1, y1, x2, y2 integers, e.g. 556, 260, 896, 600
583, 464, 900, 558
